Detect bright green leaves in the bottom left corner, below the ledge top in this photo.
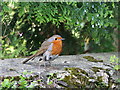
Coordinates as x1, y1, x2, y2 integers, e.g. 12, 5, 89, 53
0, 71, 37, 90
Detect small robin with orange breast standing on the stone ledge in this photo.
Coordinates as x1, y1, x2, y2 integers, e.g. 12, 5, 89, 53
23, 35, 64, 64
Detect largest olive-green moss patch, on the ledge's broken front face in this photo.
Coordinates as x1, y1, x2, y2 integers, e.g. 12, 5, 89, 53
63, 67, 89, 88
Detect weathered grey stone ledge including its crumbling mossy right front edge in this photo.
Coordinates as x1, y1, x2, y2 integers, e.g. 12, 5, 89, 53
0, 52, 119, 88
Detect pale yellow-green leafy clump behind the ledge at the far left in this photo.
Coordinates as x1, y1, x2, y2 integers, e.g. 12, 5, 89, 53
1, 35, 28, 58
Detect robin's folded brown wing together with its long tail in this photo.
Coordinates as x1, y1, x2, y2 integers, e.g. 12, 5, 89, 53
23, 41, 51, 64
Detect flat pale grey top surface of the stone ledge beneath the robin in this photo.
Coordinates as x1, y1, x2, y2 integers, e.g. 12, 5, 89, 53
0, 52, 118, 76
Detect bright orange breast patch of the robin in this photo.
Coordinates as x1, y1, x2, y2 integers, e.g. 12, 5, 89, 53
51, 40, 62, 55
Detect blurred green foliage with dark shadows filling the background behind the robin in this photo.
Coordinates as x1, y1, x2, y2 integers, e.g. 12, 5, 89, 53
0, 2, 120, 58
